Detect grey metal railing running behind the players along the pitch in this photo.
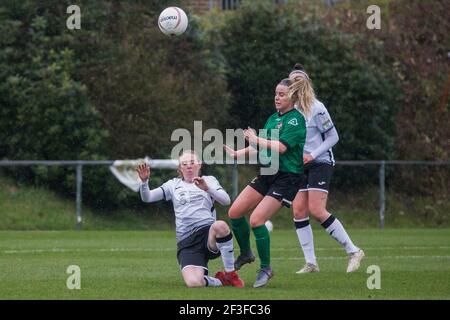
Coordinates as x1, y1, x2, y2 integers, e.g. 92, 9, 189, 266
0, 159, 450, 230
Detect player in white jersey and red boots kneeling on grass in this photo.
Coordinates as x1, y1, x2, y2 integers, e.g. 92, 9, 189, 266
136, 151, 244, 287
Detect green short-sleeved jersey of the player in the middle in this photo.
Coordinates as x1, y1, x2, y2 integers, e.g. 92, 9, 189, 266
259, 109, 306, 173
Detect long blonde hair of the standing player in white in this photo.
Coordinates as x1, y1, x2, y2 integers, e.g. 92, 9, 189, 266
288, 75, 316, 117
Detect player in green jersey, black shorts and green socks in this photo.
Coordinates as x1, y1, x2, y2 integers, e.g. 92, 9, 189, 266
224, 79, 306, 288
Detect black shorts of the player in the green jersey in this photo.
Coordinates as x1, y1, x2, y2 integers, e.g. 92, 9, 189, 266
249, 171, 304, 208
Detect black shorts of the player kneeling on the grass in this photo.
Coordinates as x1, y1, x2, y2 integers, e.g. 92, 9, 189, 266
177, 226, 220, 275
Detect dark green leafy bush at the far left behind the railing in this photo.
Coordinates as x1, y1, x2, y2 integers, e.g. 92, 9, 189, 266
0, 1, 107, 198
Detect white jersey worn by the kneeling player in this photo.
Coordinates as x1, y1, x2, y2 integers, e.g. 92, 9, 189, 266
160, 176, 224, 242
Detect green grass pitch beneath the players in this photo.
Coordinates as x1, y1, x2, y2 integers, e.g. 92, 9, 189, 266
0, 229, 450, 300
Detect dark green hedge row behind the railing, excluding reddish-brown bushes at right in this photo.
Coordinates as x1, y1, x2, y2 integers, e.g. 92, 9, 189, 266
0, 0, 400, 208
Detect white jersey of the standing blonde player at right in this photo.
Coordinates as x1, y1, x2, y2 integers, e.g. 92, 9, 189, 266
296, 99, 335, 165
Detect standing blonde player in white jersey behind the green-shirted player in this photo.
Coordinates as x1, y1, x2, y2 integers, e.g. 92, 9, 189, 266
289, 64, 364, 273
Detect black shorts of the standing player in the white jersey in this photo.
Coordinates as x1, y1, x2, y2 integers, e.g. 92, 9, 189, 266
299, 163, 334, 193
